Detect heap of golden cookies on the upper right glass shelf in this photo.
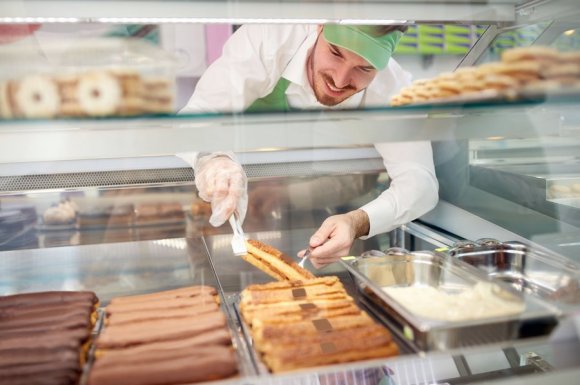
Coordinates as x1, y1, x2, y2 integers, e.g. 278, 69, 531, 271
391, 46, 580, 106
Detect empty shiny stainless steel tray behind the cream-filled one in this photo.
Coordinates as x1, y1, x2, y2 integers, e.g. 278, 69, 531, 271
449, 239, 580, 312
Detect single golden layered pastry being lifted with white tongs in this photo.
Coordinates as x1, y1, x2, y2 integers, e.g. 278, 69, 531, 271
242, 239, 314, 281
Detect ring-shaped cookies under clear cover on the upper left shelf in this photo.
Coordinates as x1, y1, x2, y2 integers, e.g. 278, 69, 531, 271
0, 37, 178, 119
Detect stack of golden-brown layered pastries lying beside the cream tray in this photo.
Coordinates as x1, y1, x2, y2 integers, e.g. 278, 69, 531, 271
240, 277, 399, 373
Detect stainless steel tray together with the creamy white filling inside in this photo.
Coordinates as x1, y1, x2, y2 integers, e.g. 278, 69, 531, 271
341, 248, 560, 351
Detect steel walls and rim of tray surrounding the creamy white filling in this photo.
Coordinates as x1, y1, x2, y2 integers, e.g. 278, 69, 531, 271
341, 249, 559, 351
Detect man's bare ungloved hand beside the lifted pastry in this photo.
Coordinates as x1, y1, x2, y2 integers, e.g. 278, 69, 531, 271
298, 210, 369, 269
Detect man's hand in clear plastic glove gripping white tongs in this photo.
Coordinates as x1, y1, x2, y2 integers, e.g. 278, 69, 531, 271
193, 153, 248, 227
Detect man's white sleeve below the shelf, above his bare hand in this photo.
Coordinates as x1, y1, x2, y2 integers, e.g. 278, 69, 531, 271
361, 142, 439, 239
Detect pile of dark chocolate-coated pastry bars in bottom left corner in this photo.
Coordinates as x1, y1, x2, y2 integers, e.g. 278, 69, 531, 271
0, 291, 98, 384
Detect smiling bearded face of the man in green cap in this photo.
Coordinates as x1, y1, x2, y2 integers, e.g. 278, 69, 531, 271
307, 32, 377, 106
